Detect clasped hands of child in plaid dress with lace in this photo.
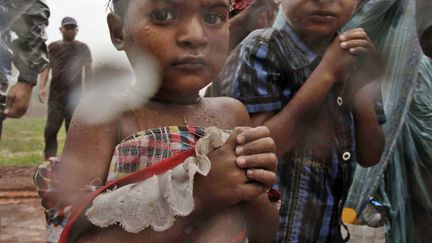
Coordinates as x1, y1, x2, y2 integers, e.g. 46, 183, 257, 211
194, 127, 277, 209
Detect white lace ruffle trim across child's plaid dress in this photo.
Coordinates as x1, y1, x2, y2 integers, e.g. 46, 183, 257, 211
85, 127, 229, 233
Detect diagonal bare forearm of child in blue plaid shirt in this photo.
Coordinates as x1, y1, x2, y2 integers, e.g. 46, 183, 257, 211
251, 39, 356, 155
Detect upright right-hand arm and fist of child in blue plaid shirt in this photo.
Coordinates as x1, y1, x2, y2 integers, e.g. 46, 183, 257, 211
340, 28, 385, 167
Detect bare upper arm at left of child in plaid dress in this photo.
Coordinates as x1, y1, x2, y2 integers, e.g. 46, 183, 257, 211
54, 103, 117, 206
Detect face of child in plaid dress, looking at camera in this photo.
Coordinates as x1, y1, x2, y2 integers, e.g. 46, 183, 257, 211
118, 0, 228, 97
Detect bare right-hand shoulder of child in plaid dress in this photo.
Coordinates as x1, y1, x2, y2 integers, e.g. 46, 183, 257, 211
205, 97, 251, 127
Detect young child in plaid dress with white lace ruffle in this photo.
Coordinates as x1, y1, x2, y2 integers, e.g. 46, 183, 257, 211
41, 0, 277, 242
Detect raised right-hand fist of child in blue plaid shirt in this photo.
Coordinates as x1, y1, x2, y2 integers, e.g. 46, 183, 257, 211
339, 28, 385, 93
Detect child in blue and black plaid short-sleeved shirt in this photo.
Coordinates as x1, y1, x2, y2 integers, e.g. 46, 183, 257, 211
213, 0, 384, 242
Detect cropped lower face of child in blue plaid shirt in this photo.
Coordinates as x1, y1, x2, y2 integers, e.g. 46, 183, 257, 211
282, 0, 357, 37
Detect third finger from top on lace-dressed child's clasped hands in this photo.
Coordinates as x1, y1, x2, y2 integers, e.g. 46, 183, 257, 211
236, 153, 278, 172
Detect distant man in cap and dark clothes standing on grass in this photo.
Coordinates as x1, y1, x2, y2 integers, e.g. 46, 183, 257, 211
39, 17, 92, 159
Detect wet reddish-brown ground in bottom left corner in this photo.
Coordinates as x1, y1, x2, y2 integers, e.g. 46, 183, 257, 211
0, 167, 45, 242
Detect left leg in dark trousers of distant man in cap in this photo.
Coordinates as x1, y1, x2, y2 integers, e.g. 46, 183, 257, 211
44, 99, 64, 159
